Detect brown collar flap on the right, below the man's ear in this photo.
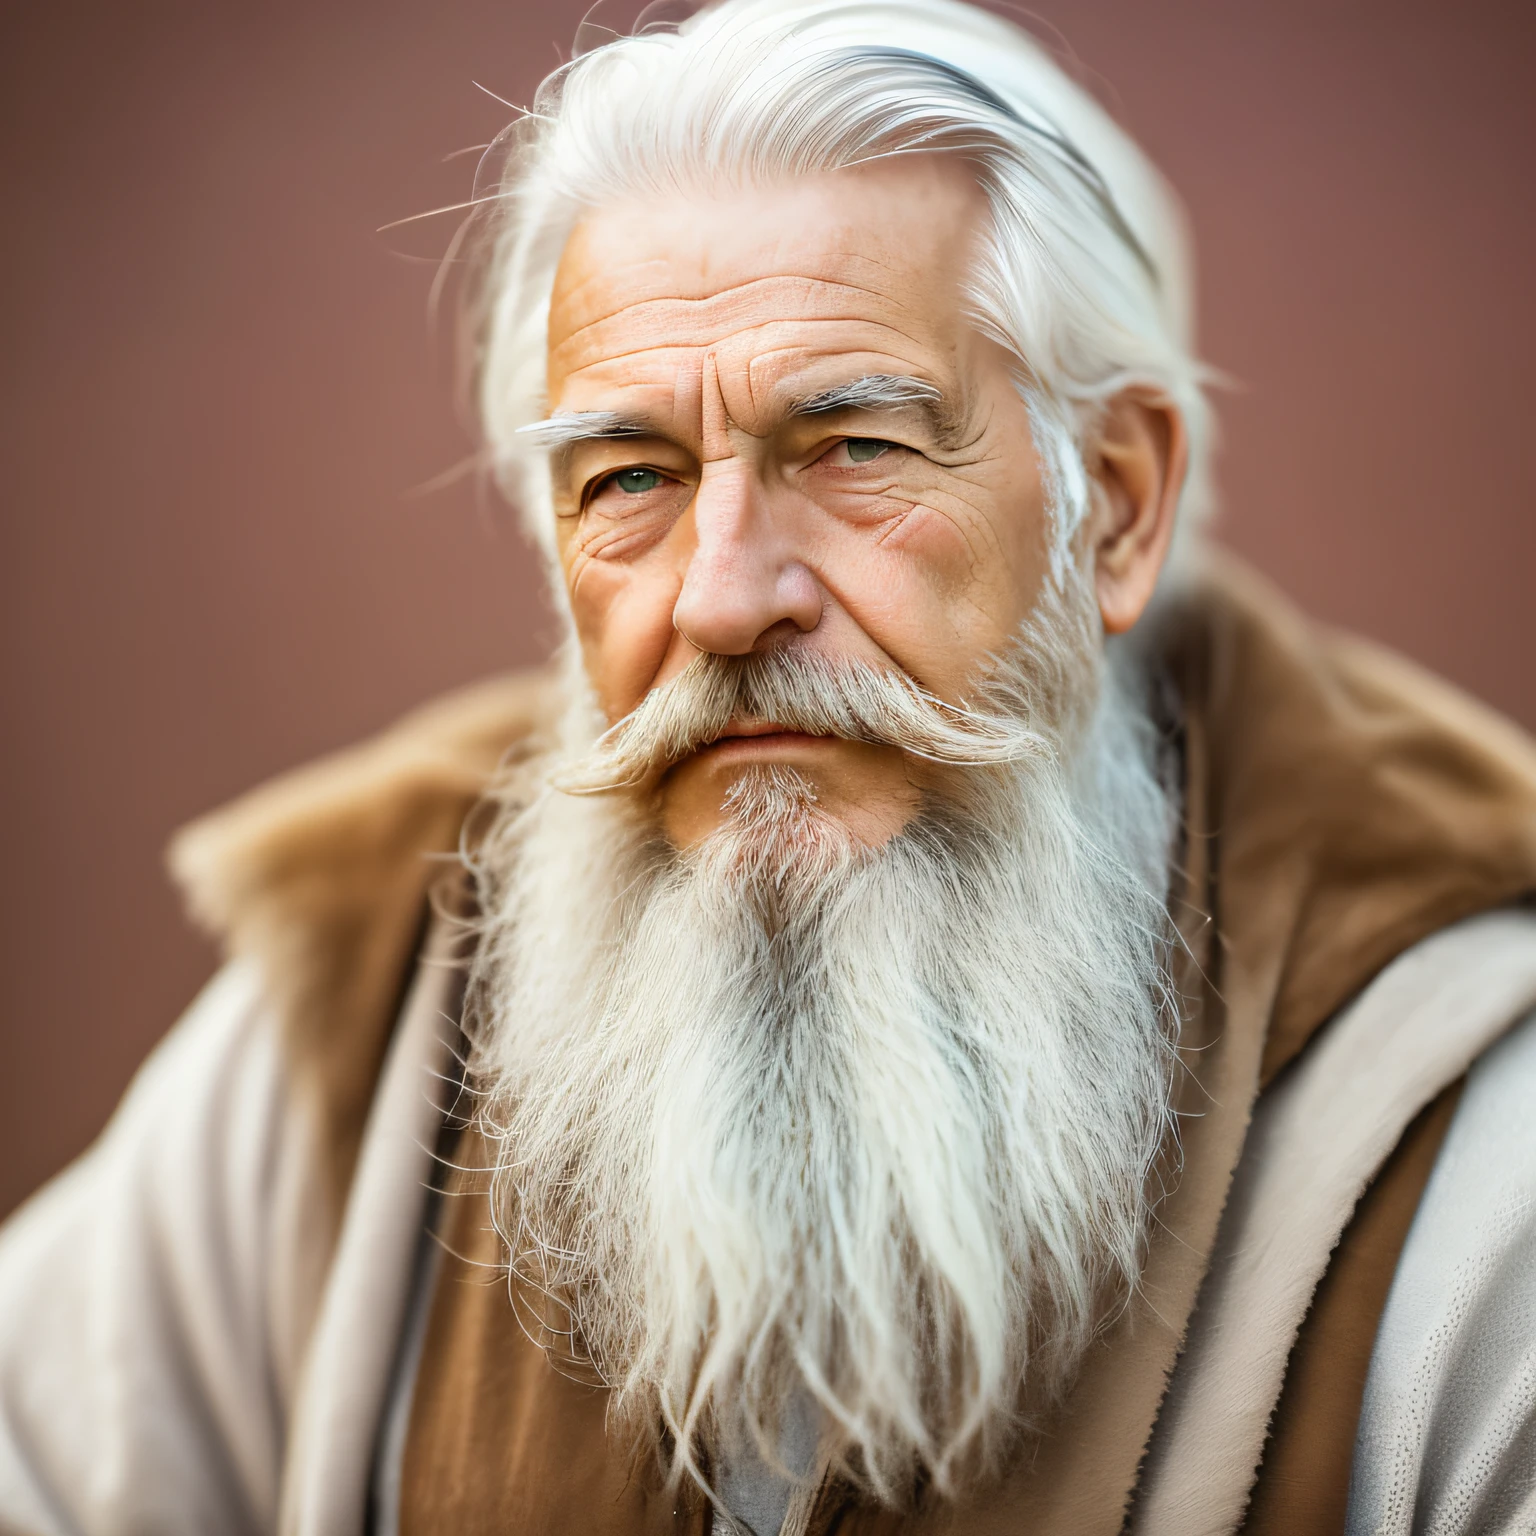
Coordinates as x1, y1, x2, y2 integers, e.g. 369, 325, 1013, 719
1161, 556, 1536, 1081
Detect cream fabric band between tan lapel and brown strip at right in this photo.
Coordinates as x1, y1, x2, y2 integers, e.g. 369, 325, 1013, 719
1132, 911, 1536, 1536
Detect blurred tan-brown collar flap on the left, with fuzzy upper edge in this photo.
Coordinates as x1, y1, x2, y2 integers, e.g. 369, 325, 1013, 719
170, 670, 554, 1210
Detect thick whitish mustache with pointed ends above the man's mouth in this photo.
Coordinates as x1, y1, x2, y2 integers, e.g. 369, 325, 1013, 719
554, 650, 1051, 794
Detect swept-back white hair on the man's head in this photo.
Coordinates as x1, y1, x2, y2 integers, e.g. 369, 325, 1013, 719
475, 0, 1212, 584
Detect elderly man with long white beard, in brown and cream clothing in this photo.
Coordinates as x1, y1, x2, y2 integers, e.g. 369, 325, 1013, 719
0, 0, 1536, 1536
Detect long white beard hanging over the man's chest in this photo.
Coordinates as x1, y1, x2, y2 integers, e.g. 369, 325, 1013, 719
472, 595, 1174, 1501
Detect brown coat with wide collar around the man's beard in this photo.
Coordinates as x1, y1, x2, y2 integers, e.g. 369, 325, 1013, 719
175, 552, 1536, 1536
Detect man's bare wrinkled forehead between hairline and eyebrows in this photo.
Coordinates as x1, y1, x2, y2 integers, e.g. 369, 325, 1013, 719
548, 155, 985, 425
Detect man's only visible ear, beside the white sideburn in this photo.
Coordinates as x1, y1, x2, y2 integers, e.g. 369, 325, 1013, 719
1087, 389, 1189, 634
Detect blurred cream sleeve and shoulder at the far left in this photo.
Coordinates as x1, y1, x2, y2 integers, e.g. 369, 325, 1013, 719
0, 963, 304, 1536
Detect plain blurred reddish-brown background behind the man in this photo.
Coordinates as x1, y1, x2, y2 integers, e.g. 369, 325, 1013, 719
0, 0, 1536, 1212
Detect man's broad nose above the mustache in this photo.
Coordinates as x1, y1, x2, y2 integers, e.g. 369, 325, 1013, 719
673, 459, 822, 656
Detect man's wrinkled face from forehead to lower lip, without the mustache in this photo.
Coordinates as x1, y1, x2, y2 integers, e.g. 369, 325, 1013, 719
548, 155, 1049, 846
